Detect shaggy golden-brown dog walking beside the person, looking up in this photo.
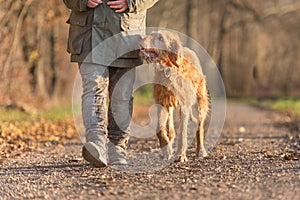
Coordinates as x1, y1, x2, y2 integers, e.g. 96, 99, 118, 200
138, 31, 209, 162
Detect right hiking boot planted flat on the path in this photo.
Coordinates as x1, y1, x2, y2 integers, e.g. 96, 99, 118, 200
107, 142, 128, 165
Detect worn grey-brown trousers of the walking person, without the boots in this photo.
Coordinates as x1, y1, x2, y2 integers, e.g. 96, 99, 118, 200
79, 63, 135, 149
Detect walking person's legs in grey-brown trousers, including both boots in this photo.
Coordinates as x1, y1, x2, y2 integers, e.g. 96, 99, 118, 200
80, 63, 135, 167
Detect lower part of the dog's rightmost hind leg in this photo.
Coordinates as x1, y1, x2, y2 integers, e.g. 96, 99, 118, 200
196, 110, 207, 157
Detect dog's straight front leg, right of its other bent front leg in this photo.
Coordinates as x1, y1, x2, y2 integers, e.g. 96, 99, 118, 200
176, 108, 190, 162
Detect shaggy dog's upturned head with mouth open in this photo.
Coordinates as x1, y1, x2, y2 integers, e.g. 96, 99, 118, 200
138, 31, 183, 67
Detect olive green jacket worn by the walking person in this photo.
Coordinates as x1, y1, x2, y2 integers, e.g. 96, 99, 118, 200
63, 0, 158, 67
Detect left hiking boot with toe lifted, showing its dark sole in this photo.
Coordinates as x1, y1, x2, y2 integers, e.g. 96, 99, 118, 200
82, 142, 107, 167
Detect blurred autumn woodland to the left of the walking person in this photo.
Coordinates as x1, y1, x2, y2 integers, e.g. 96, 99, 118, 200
0, 0, 76, 108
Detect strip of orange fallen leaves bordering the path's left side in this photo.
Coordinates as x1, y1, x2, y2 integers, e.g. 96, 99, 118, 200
0, 117, 78, 160
